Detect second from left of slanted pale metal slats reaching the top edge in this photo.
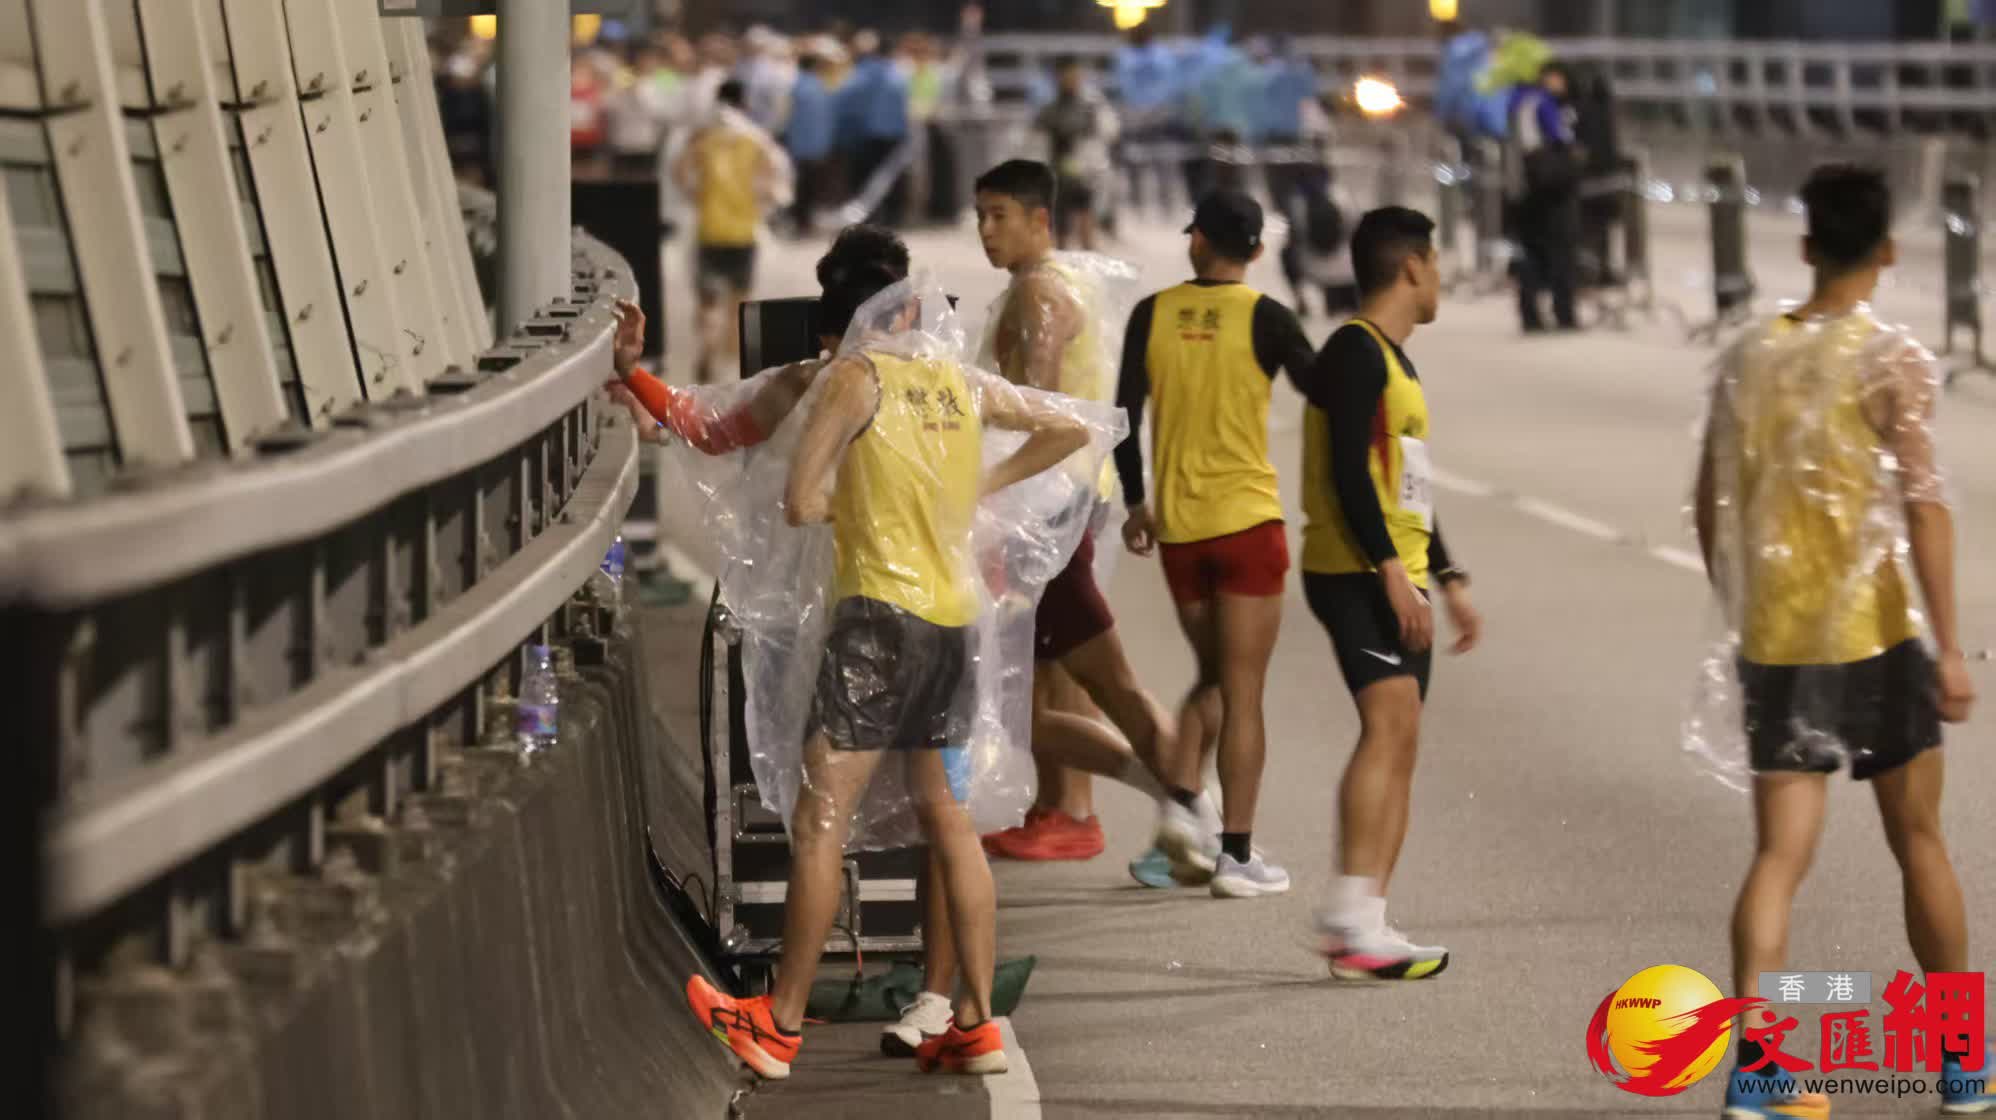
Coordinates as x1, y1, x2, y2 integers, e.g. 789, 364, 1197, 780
138, 0, 289, 451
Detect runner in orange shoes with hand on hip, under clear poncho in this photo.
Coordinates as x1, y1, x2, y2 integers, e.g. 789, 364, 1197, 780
687, 240, 1088, 1078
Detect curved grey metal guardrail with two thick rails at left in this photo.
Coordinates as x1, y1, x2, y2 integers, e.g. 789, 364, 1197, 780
0, 187, 637, 998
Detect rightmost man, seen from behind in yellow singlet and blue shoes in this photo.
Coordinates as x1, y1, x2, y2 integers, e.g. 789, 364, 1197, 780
1689, 166, 1996, 1120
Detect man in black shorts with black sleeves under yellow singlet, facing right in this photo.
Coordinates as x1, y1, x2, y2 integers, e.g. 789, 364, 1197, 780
1303, 208, 1481, 980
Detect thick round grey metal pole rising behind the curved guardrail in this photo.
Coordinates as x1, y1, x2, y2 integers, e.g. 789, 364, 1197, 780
499, 0, 569, 335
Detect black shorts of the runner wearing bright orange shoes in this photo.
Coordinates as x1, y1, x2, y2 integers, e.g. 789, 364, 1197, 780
810, 597, 976, 751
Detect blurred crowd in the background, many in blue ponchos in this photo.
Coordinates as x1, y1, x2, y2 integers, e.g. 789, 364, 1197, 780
431, 14, 1623, 327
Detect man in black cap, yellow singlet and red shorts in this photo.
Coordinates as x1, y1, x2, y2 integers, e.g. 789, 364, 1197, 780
1116, 192, 1311, 898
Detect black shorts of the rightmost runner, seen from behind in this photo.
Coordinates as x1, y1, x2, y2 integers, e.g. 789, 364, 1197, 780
1741, 639, 1940, 781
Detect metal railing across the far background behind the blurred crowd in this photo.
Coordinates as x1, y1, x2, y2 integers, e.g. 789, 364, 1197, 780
982, 34, 1996, 136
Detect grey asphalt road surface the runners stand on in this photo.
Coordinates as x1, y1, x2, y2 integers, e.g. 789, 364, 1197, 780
646, 210, 1996, 1120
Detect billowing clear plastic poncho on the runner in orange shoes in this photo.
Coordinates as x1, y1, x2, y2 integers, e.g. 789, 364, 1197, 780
654, 276, 1126, 848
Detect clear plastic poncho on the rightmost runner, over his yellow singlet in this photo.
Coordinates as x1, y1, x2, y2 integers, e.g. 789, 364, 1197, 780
1683, 307, 1946, 789
